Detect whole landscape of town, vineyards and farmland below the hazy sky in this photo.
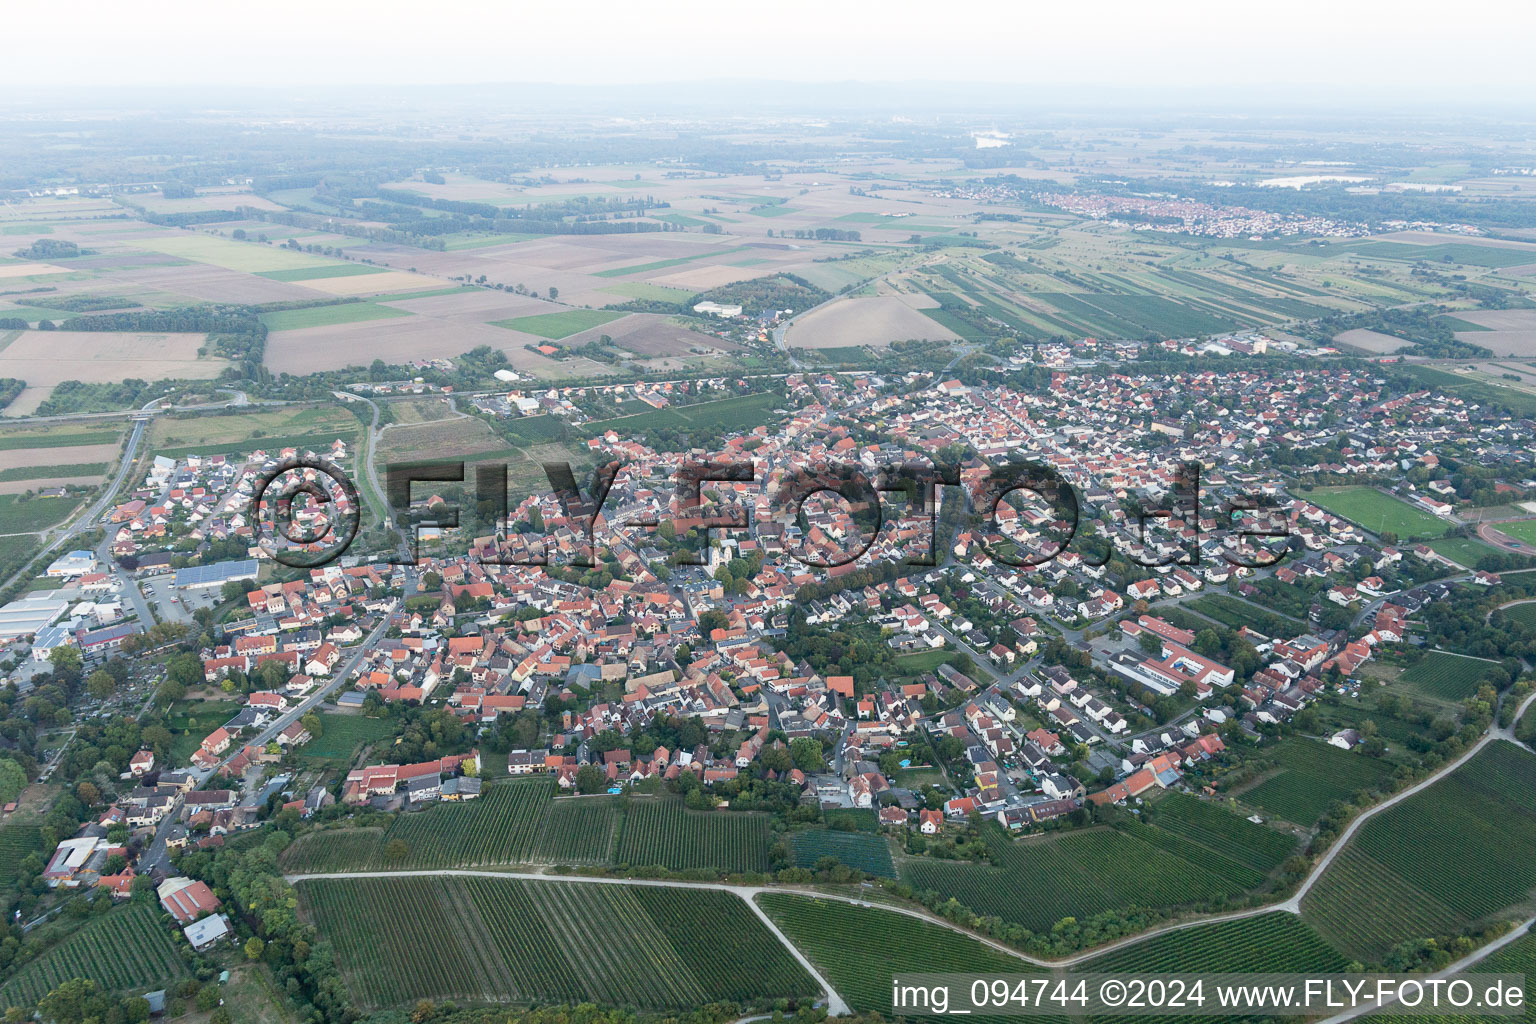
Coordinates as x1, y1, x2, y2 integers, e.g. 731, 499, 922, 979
0, 54, 1536, 1024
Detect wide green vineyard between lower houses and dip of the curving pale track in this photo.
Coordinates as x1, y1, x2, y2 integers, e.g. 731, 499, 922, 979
902, 826, 1261, 932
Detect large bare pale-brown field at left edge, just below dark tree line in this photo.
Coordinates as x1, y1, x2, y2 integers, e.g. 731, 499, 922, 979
0, 330, 229, 416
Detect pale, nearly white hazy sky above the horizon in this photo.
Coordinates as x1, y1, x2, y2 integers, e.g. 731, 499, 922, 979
12, 0, 1536, 104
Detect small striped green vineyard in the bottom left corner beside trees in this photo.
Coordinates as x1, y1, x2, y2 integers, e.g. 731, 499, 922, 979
0, 903, 189, 1007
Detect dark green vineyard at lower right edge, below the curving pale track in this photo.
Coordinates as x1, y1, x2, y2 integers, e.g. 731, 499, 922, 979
1301, 742, 1536, 963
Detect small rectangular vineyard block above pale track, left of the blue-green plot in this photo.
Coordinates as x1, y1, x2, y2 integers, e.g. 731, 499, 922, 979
614, 798, 768, 874
